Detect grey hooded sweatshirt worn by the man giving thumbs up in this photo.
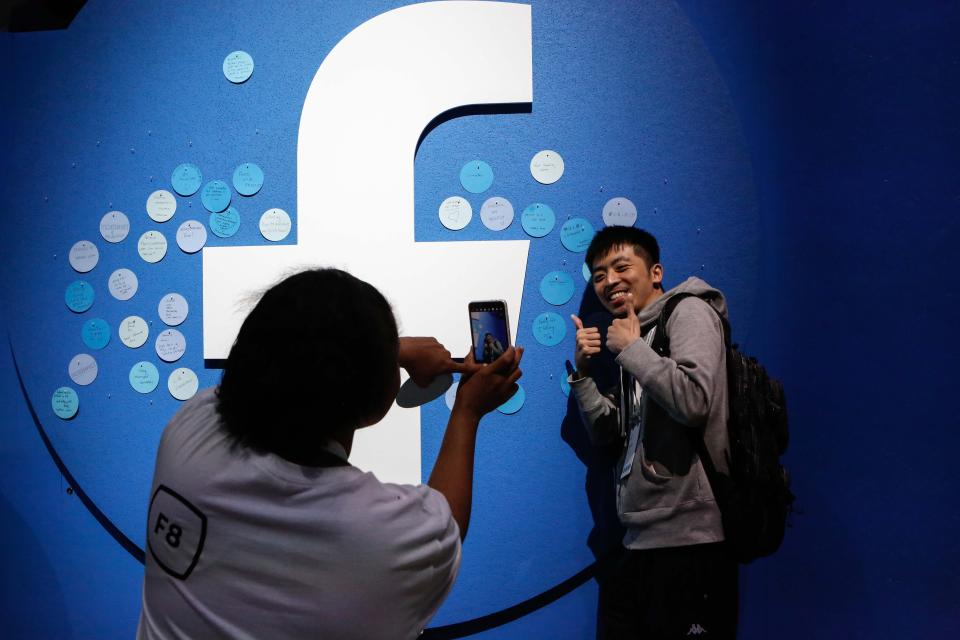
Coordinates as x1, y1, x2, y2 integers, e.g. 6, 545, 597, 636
570, 278, 728, 549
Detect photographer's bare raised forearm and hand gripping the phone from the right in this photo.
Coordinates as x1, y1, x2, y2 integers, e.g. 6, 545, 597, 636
427, 347, 523, 540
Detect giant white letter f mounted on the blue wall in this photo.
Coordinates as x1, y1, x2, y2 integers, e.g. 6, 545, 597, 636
203, 2, 533, 483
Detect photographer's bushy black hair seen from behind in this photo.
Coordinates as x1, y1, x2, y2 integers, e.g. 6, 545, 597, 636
217, 269, 399, 457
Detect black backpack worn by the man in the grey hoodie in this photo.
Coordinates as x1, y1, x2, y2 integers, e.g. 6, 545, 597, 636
652, 293, 794, 563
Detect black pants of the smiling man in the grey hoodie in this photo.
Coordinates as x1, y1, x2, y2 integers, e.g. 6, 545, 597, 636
597, 544, 738, 640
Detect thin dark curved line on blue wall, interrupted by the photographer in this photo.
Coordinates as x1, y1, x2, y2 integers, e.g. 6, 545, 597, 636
13, 334, 597, 640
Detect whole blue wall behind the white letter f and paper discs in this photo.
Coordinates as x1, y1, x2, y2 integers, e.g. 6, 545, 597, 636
0, 0, 960, 639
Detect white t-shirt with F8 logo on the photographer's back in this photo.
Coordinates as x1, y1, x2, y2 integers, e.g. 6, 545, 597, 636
137, 389, 460, 640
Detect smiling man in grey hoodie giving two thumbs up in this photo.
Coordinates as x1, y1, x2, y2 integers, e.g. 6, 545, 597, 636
570, 227, 737, 639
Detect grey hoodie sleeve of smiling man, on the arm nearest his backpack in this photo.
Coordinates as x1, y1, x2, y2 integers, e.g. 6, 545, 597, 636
617, 297, 724, 427
